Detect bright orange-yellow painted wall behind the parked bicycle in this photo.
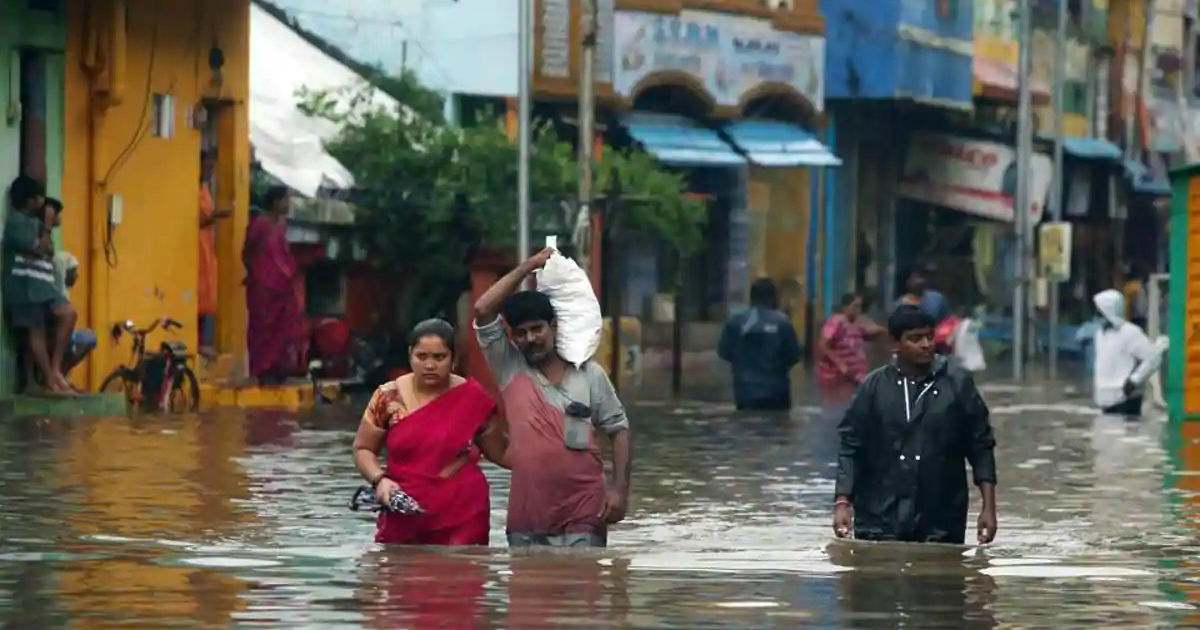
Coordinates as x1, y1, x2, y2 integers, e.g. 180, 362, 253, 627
62, 0, 250, 388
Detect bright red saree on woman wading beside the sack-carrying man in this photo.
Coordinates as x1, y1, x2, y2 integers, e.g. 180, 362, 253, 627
367, 379, 496, 545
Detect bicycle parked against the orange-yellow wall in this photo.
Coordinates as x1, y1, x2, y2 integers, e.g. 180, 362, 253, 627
100, 317, 200, 413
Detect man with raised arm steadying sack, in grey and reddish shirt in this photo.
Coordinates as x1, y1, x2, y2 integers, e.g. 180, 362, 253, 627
475, 248, 632, 547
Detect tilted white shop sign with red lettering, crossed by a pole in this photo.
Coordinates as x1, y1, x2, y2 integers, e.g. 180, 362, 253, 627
900, 133, 1054, 223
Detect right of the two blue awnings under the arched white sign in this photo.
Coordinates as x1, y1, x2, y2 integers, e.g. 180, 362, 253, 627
725, 120, 841, 167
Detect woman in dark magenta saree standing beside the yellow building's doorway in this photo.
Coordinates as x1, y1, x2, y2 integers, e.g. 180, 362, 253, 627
242, 186, 304, 384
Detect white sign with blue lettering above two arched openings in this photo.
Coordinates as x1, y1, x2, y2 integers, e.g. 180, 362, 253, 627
613, 11, 824, 110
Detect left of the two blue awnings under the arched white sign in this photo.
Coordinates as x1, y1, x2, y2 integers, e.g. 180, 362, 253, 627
624, 113, 746, 167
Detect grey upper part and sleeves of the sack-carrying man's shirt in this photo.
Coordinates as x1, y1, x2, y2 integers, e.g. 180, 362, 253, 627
475, 317, 629, 434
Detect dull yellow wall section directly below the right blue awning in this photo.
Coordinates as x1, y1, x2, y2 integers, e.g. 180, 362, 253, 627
749, 167, 812, 331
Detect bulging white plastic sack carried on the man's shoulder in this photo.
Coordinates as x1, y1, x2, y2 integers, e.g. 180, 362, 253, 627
538, 252, 604, 367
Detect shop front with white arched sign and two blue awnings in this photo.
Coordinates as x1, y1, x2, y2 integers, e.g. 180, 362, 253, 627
612, 2, 840, 338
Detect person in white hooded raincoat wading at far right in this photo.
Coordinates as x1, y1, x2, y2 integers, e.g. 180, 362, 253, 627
1092, 289, 1163, 416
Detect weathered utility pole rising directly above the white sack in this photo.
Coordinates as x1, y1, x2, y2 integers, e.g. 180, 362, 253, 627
572, 0, 598, 269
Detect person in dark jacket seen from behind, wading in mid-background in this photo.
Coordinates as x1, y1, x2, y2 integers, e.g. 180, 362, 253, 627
716, 278, 800, 412
